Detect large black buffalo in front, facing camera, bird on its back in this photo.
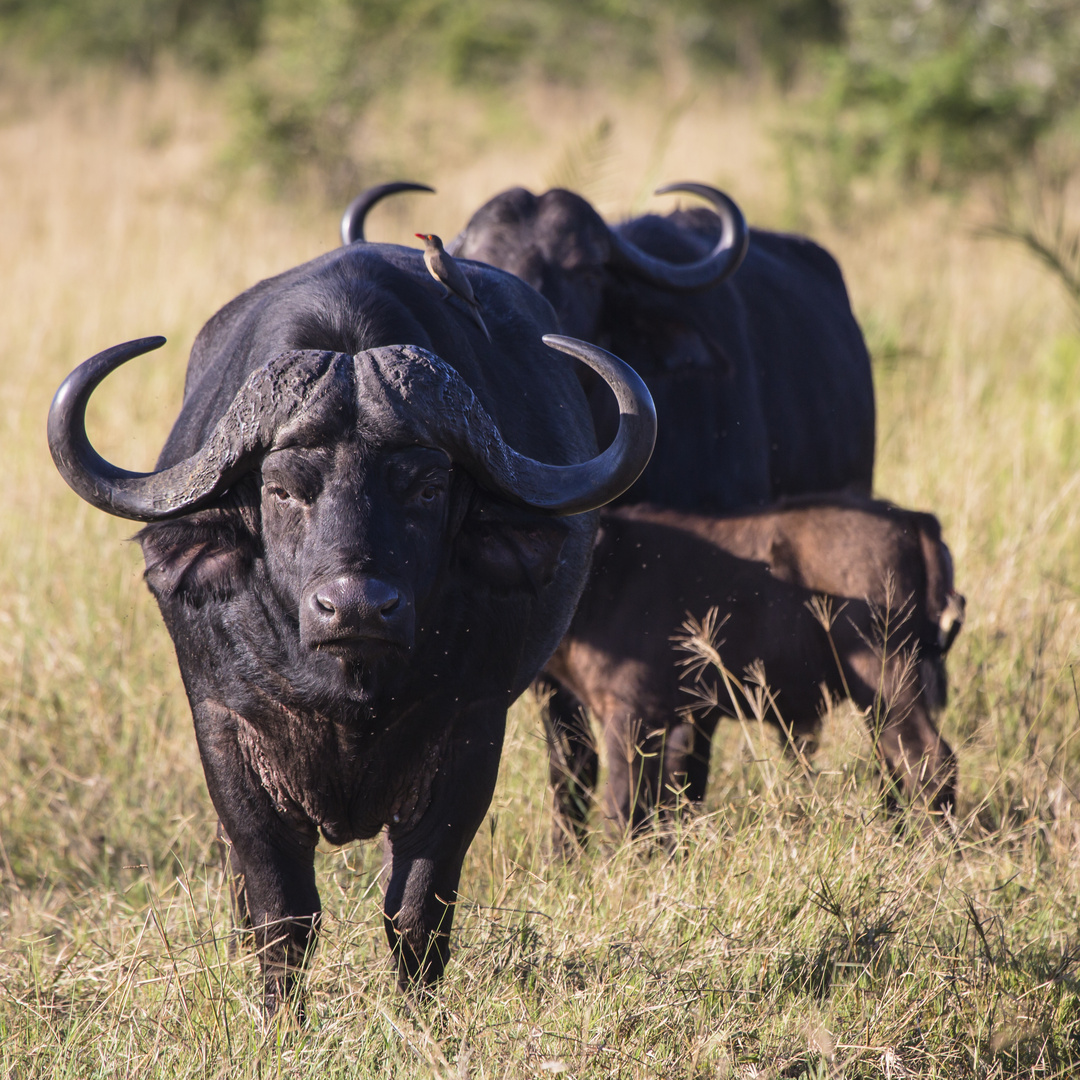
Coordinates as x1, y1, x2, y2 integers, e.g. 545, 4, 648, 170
50, 238, 654, 1011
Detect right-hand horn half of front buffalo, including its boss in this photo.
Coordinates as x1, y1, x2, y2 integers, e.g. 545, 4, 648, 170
356, 334, 657, 515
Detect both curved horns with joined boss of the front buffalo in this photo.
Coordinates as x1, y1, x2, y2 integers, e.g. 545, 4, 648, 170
49, 335, 657, 522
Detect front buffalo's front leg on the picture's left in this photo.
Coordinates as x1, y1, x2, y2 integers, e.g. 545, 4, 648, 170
195, 702, 321, 1018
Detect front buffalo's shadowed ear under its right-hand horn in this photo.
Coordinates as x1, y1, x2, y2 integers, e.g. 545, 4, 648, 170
457, 507, 569, 592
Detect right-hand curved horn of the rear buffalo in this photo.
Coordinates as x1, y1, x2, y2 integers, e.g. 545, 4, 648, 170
608, 183, 750, 293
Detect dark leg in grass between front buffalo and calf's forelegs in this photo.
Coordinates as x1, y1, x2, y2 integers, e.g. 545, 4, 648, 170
532, 675, 599, 856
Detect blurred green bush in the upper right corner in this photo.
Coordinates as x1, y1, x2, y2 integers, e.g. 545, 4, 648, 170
812, 0, 1080, 188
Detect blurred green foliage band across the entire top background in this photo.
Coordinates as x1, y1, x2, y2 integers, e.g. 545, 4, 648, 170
8, 0, 1080, 203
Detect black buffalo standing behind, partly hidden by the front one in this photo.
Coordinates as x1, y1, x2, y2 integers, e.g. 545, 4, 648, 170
342, 183, 875, 513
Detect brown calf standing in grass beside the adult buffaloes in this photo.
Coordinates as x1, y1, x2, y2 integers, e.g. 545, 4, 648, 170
539, 495, 964, 848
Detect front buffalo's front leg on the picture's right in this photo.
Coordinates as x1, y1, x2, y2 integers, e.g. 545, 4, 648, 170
382, 701, 507, 987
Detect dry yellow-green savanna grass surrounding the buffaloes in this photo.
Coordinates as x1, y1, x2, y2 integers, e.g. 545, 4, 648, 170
0, 73, 1080, 1078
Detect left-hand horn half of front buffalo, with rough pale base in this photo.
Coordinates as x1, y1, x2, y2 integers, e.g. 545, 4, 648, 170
49, 337, 343, 522
